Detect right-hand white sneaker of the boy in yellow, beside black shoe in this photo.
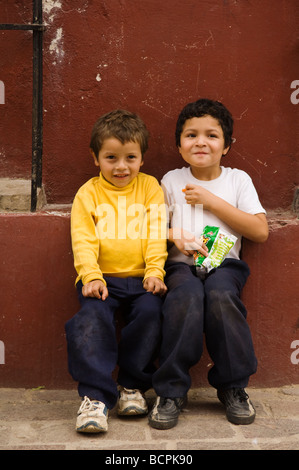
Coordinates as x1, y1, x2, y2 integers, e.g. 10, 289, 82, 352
117, 387, 148, 416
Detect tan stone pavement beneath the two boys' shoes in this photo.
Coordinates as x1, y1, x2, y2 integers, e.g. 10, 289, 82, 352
0, 385, 299, 452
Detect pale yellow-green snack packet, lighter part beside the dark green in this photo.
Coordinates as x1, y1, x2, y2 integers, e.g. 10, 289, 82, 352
202, 228, 237, 272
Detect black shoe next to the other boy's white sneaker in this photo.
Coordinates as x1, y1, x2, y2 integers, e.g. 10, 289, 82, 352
148, 397, 187, 429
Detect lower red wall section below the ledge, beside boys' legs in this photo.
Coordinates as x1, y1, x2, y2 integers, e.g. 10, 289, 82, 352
0, 212, 299, 388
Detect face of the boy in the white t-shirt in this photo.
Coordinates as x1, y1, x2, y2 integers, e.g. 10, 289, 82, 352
179, 115, 229, 177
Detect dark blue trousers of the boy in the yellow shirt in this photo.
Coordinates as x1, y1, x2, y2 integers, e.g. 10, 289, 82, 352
65, 277, 162, 409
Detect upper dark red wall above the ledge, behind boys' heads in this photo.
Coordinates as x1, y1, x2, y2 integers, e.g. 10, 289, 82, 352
0, 0, 299, 208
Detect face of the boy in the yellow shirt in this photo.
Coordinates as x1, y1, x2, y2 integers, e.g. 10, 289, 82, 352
93, 137, 143, 188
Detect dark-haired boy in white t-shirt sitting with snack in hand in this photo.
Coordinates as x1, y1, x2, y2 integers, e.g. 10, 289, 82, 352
149, 99, 268, 429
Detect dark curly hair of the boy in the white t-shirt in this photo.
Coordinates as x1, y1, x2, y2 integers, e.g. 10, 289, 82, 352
175, 98, 234, 148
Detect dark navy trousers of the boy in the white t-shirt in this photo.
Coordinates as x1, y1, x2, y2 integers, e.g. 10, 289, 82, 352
153, 259, 257, 398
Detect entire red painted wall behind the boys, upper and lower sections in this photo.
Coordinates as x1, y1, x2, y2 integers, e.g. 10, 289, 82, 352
0, 0, 299, 387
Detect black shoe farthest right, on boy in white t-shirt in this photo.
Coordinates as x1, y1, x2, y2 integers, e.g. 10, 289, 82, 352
217, 388, 255, 424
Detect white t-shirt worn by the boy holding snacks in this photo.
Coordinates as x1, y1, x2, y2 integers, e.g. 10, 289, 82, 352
161, 166, 266, 265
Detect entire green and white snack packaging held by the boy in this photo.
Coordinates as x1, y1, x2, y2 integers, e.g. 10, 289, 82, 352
194, 226, 237, 272
